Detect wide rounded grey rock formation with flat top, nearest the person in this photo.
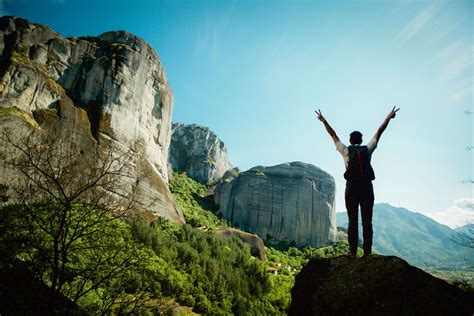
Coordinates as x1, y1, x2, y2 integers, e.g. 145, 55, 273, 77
214, 162, 336, 247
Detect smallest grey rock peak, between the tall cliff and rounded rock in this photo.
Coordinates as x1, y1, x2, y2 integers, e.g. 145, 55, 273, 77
169, 124, 232, 184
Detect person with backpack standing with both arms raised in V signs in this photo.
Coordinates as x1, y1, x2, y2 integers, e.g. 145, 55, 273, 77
315, 107, 400, 259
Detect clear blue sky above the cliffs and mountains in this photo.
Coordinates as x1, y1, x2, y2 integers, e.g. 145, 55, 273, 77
0, 0, 474, 226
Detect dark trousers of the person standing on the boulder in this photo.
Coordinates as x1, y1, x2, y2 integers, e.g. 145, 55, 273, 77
345, 180, 374, 255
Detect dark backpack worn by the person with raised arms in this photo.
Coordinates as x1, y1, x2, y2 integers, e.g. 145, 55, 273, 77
344, 146, 375, 180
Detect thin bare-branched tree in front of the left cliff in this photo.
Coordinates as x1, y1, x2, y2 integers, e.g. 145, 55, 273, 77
0, 129, 143, 313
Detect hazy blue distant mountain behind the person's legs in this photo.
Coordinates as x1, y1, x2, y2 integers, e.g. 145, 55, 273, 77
336, 203, 474, 270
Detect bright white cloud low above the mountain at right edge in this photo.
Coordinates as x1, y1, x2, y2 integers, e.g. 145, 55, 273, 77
425, 197, 474, 228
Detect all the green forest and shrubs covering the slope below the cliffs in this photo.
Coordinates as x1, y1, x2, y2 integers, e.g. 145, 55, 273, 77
0, 174, 366, 315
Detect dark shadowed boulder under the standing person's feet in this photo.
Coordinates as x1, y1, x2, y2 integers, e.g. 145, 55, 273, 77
288, 256, 474, 316
